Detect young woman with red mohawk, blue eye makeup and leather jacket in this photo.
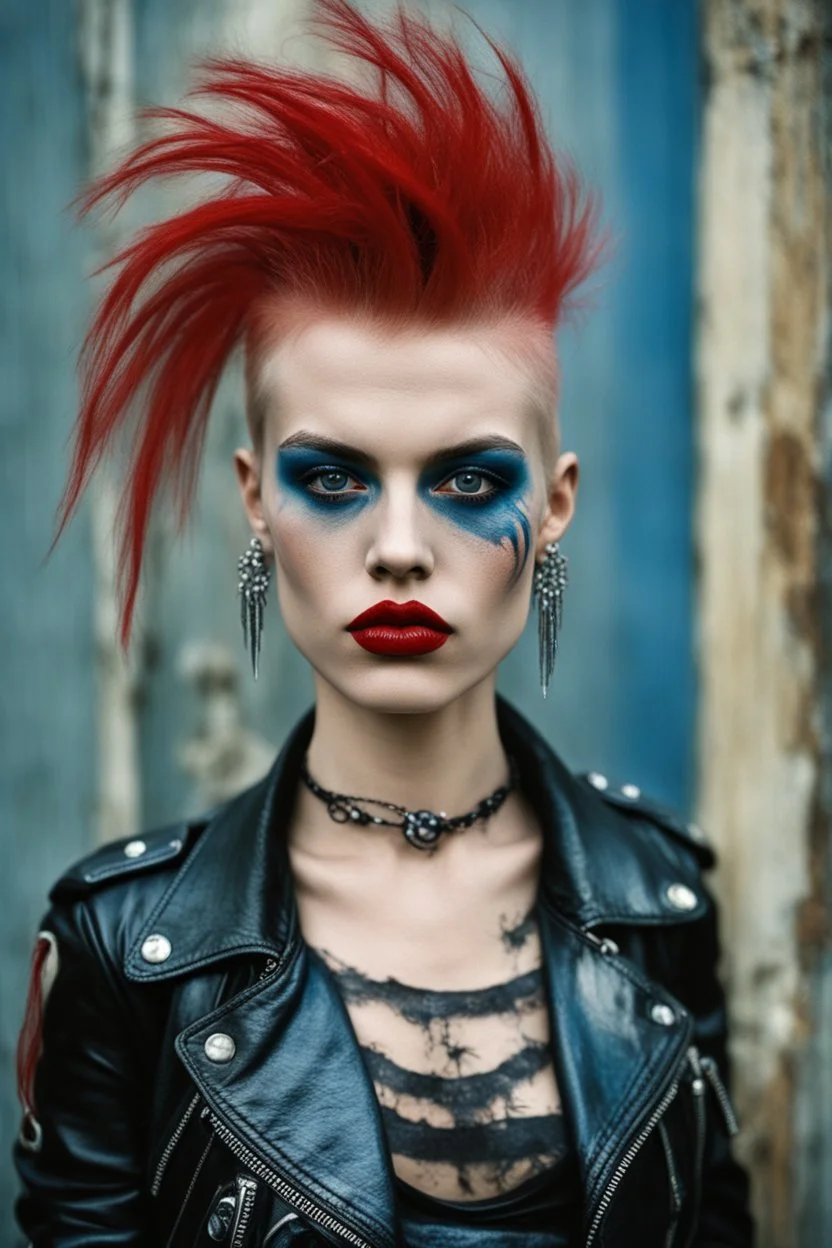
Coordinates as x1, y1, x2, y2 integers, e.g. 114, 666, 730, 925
15, 0, 752, 1248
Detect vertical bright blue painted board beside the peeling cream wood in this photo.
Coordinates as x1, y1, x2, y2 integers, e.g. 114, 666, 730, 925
601, 0, 699, 807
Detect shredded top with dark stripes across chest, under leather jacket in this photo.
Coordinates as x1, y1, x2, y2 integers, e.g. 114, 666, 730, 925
318, 914, 580, 1248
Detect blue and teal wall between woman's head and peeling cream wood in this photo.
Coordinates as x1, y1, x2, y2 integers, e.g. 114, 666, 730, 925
491, 0, 697, 809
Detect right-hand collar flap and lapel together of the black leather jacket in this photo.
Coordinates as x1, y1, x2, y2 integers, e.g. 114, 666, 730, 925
498, 700, 706, 1228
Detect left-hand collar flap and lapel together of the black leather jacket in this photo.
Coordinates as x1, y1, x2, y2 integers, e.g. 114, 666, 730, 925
125, 710, 395, 1248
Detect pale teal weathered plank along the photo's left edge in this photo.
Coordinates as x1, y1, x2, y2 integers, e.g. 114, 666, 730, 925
0, 0, 95, 1246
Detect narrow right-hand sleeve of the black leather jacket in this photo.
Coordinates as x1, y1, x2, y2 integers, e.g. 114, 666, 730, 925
679, 882, 755, 1248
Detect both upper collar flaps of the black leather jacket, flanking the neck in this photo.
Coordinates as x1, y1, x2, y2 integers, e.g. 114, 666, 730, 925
125, 695, 705, 981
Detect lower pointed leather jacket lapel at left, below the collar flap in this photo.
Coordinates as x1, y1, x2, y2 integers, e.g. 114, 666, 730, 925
176, 942, 395, 1248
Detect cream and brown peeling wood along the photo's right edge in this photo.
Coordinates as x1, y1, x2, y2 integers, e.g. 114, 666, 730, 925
697, 0, 832, 1248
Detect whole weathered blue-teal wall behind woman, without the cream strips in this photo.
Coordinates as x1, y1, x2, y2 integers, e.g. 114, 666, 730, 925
0, 0, 697, 1244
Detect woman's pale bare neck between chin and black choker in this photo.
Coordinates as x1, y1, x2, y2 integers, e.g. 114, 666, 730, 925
298, 676, 509, 836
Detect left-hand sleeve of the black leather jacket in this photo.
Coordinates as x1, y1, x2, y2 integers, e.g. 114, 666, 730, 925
14, 899, 150, 1248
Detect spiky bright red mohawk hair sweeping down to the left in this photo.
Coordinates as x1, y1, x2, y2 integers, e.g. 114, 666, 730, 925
55, 0, 600, 645
